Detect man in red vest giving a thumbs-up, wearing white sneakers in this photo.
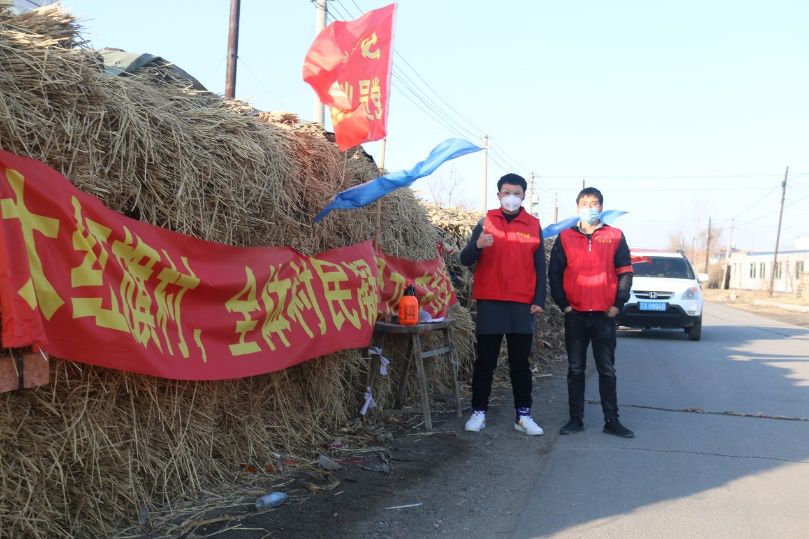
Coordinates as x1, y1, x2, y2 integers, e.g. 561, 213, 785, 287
461, 174, 545, 436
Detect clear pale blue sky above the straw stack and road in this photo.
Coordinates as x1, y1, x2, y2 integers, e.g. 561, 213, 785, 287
64, 0, 809, 250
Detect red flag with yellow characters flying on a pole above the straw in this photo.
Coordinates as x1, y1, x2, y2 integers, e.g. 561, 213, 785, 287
303, 4, 396, 150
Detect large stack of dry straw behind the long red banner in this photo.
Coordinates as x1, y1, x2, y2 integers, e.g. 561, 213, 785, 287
0, 8, 473, 537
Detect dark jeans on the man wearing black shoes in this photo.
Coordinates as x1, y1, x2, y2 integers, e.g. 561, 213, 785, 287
565, 311, 618, 421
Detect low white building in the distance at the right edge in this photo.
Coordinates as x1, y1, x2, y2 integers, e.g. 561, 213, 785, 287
728, 249, 809, 293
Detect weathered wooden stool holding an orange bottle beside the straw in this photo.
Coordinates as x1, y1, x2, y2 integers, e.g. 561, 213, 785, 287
368, 320, 461, 432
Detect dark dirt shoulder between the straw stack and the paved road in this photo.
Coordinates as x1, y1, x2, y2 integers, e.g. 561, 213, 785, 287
168, 358, 567, 539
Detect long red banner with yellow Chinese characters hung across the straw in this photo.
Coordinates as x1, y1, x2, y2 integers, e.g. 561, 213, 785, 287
0, 151, 455, 380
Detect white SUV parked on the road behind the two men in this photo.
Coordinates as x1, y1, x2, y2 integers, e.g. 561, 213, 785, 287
618, 251, 708, 341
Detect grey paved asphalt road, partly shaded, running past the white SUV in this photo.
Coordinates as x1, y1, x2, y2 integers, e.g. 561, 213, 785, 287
512, 304, 809, 538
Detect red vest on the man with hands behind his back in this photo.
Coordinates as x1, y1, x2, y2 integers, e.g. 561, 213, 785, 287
559, 225, 632, 312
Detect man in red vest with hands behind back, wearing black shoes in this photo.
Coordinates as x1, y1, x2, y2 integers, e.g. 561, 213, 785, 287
548, 187, 635, 438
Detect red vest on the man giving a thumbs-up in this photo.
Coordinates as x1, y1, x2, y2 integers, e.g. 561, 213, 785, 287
472, 208, 540, 304
